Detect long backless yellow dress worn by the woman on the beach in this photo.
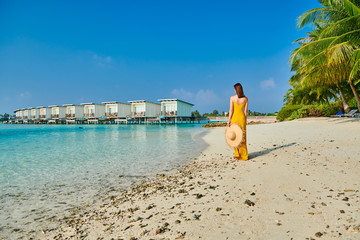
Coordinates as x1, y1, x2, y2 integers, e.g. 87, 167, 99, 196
231, 102, 248, 161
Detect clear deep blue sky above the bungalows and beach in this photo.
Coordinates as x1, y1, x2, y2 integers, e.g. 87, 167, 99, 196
0, 0, 319, 113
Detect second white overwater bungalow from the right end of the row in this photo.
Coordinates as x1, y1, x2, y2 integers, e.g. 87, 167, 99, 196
129, 100, 161, 118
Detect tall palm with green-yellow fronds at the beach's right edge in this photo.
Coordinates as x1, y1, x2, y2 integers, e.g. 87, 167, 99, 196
290, 0, 360, 111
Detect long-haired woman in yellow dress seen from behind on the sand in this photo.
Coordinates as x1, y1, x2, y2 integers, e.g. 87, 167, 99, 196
228, 83, 248, 161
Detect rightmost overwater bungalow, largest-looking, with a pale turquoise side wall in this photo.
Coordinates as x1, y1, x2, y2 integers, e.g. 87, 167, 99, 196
158, 99, 194, 117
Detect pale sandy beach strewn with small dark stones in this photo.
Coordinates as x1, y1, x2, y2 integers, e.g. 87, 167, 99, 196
35, 118, 360, 239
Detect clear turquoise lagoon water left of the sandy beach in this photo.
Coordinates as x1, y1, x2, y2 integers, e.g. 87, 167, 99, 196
0, 124, 205, 238
